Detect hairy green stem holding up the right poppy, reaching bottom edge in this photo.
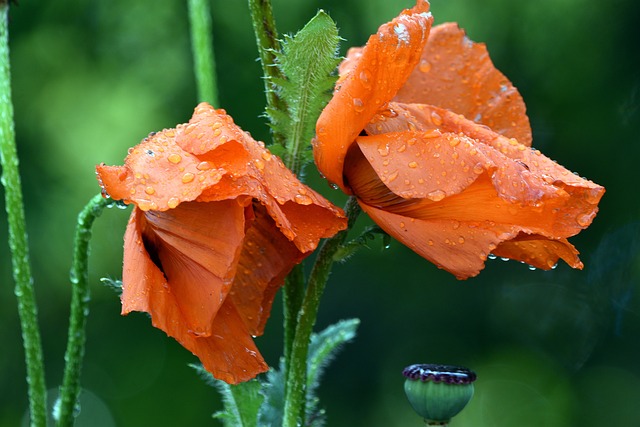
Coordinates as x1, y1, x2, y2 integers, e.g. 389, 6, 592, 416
283, 197, 360, 427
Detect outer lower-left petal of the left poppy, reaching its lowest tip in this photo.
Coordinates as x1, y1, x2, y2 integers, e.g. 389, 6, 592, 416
122, 209, 268, 384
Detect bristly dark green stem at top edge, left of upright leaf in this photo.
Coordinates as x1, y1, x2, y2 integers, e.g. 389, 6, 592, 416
249, 0, 286, 145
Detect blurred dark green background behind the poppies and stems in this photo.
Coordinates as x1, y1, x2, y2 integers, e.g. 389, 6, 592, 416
0, 0, 640, 427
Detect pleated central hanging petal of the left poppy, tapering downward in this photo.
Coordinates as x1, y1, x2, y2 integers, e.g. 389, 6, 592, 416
142, 199, 249, 336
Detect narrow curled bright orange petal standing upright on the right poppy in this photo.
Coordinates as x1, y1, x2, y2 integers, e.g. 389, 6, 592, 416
313, 0, 433, 192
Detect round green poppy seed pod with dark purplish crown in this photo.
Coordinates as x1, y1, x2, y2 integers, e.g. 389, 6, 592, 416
402, 364, 476, 426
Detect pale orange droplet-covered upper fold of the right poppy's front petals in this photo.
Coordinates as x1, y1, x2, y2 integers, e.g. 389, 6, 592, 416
358, 103, 604, 219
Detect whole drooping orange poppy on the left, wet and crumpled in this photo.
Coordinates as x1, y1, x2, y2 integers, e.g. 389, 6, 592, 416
97, 103, 346, 383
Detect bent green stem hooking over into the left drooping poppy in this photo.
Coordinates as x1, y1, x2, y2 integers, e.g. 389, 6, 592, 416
54, 194, 124, 427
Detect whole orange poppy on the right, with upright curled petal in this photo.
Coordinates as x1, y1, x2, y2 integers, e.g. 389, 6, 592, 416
313, 0, 604, 279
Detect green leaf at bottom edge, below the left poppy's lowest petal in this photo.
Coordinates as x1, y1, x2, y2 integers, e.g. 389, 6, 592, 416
189, 364, 264, 427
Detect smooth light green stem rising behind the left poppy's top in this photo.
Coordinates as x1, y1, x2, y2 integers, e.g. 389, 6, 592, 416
189, 0, 220, 108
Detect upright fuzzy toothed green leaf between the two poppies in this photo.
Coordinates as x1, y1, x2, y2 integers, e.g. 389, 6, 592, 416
267, 10, 340, 173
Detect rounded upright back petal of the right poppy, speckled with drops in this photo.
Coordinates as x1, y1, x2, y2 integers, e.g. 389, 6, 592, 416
394, 23, 532, 146
